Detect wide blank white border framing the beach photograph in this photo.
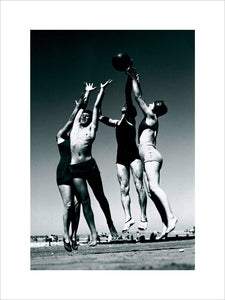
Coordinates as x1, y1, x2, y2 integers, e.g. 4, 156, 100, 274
1, 1, 224, 299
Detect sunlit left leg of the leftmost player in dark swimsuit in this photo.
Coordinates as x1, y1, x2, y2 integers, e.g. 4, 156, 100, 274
58, 184, 73, 243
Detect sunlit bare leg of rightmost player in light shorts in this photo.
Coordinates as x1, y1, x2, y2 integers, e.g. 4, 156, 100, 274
145, 161, 177, 236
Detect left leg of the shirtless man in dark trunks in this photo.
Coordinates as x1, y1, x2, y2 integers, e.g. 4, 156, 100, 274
73, 178, 97, 246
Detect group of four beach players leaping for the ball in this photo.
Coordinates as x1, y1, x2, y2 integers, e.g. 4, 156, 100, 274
56, 67, 177, 252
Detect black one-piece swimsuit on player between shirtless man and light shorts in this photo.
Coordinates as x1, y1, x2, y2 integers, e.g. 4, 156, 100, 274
116, 118, 140, 167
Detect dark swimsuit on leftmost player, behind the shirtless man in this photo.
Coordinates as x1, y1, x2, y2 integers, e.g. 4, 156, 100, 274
56, 138, 71, 185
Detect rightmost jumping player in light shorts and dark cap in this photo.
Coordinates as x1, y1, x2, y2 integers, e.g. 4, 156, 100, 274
127, 68, 177, 239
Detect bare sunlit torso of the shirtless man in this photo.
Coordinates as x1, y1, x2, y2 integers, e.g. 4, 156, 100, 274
70, 123, 94, 164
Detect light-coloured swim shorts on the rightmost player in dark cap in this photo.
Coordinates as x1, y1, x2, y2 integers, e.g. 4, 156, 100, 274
138, 143, 163, 164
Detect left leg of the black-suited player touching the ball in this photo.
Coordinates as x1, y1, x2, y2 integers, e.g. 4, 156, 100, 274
116, 164, 134, 231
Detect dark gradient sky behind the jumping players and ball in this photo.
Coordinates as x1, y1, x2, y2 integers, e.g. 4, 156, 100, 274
31, 30, 195, 235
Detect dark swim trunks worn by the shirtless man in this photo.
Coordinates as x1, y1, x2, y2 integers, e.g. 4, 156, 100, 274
69, 158, 100, 180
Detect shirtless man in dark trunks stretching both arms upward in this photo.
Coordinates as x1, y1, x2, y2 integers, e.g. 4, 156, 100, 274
70, 80, 118, 246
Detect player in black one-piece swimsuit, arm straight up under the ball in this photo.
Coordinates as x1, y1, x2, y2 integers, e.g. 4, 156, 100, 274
99, 76, 148, 232
